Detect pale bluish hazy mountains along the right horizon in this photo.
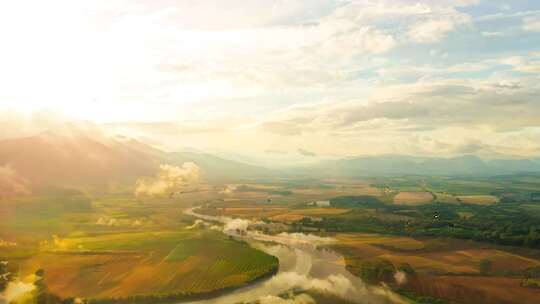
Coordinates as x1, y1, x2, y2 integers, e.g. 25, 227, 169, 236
302, 155, 540, 177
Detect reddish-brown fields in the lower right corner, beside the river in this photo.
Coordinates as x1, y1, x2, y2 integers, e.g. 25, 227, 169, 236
333, 233, 540, 304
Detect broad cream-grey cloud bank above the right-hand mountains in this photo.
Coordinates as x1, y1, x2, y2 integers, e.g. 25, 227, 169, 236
248, 73, 540, 156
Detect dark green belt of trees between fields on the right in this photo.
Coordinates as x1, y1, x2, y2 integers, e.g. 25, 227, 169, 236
296, 190, 540, 248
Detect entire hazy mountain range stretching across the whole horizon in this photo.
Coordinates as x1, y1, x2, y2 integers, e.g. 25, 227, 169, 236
0, 130, 540, 192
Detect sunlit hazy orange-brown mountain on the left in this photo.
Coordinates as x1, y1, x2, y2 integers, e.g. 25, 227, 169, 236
0, 131, 268, 186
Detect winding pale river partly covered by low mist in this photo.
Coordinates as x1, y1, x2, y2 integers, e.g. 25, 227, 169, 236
181, 208, 407, 304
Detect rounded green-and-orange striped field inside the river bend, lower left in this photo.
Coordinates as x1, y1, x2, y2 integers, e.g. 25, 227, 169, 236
17, 230, 277, 298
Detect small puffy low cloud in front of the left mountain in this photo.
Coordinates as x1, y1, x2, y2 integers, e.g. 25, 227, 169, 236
135, 162, 201, 197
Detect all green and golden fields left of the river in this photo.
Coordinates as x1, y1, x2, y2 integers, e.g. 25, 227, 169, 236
4, 192, 278, 299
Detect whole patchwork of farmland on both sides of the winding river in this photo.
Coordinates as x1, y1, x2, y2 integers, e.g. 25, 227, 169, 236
0, 173, 540, 303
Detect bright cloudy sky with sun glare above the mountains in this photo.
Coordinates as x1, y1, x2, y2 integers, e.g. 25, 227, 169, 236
0, 0, 540, 159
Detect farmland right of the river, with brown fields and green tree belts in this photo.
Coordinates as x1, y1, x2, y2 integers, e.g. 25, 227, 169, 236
195, 177, 540, 304
